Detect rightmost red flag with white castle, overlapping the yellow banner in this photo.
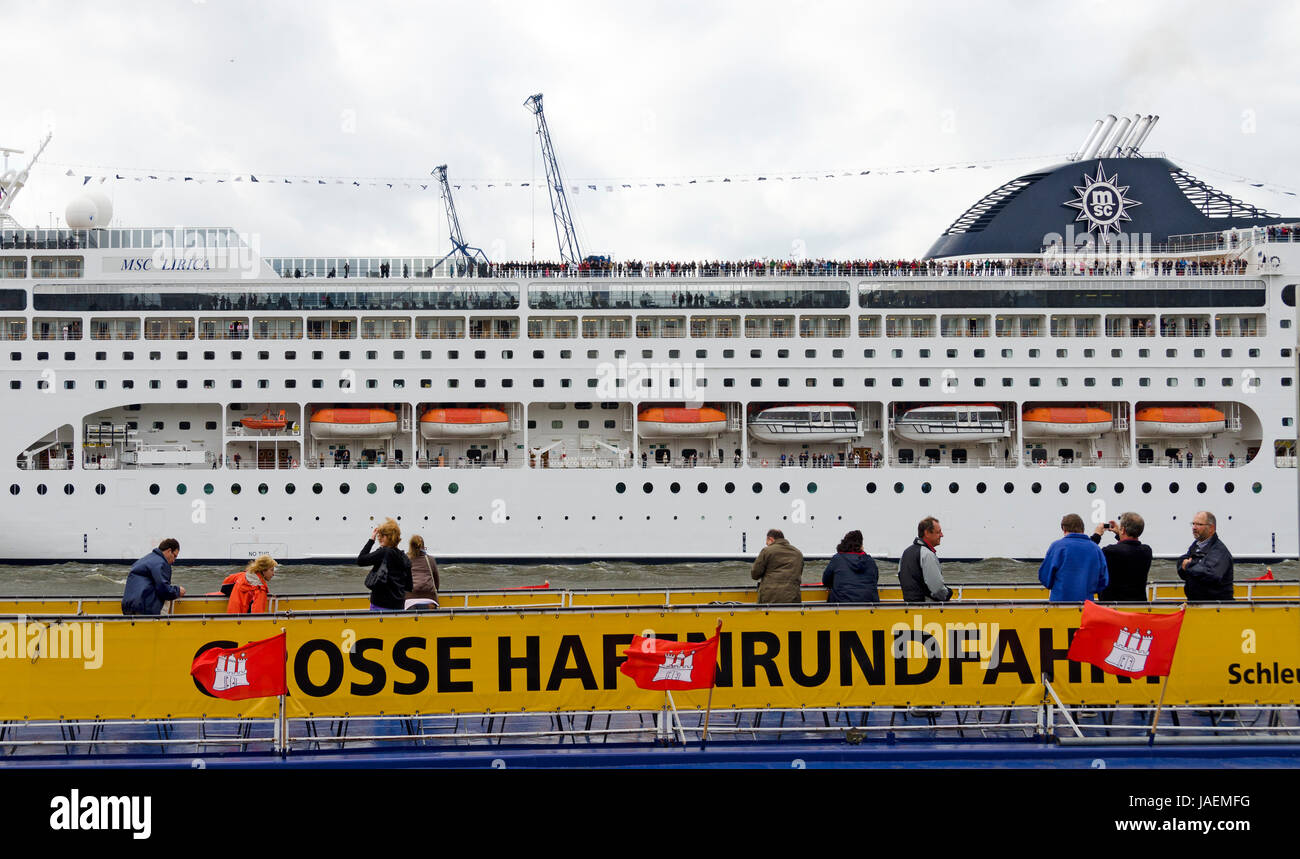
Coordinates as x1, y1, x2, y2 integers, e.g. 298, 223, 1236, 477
1069, 600, 1186, 677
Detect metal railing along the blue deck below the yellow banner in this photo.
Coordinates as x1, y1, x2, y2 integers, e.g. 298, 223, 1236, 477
0, 697, 1300, 760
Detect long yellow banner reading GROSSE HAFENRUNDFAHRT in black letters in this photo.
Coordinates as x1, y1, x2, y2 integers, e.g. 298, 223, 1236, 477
0, 604, 1300, 720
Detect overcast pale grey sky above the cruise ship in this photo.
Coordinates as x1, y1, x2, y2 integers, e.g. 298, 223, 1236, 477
0, 0, 1300, 260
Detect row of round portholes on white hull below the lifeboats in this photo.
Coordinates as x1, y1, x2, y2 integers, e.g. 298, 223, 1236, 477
9, 481, 1264, 499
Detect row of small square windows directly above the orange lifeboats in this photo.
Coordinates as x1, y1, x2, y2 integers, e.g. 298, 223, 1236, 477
9, 370, 1295, 394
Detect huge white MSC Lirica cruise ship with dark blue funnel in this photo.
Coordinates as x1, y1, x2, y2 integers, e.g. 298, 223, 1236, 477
0, 117, 1300, 563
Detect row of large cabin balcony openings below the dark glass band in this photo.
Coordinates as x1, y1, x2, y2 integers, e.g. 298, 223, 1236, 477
0, 311, 1268, 340
